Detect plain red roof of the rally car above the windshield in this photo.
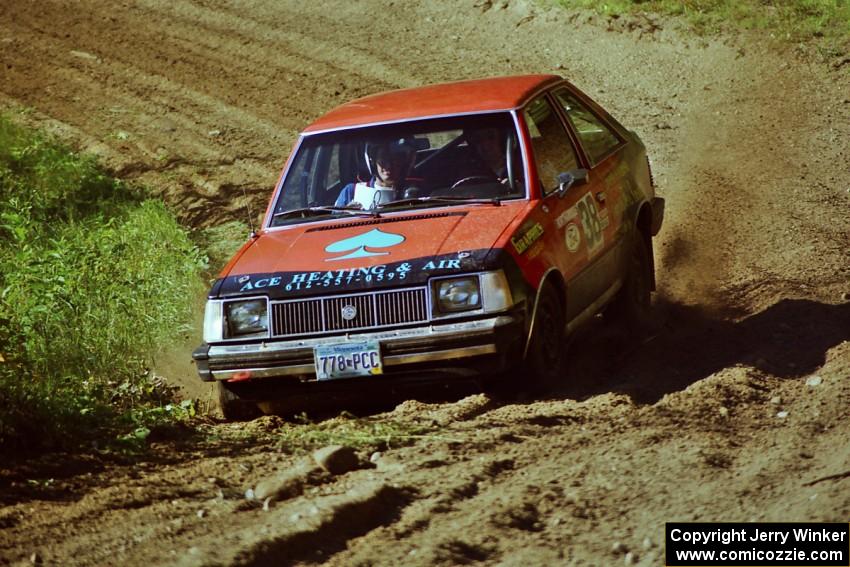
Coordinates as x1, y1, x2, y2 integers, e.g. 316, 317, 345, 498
304, 75, 562, 134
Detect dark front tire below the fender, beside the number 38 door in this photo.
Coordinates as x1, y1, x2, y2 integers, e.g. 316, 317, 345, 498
526, 284, 566, 388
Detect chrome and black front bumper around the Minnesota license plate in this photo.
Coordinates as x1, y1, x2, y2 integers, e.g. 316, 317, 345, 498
192, 314, 524, 383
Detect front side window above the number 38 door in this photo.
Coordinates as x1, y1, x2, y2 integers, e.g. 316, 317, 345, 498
523, 96, 578, 194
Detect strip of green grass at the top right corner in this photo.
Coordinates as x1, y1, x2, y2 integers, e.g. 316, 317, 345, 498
554, 0, 850, 52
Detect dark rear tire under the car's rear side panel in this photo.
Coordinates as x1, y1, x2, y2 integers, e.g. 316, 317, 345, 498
608, 233, 652, 335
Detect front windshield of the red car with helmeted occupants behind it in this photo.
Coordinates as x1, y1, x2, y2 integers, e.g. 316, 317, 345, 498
271, 112, 525, 226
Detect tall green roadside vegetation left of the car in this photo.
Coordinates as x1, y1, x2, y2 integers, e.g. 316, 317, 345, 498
0, 116, 206, 453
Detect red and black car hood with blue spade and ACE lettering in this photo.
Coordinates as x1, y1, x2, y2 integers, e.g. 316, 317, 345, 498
211, 202, 525, 299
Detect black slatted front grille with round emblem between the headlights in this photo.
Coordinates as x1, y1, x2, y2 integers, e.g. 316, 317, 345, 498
271, 287, 428, 337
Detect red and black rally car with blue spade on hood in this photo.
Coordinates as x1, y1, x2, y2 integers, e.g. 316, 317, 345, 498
193, 75, 664, 417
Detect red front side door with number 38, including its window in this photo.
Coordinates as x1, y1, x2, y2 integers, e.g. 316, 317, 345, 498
523, 95, 610, 320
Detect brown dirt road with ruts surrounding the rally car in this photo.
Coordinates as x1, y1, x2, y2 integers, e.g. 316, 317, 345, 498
0, 0, 850, 565
